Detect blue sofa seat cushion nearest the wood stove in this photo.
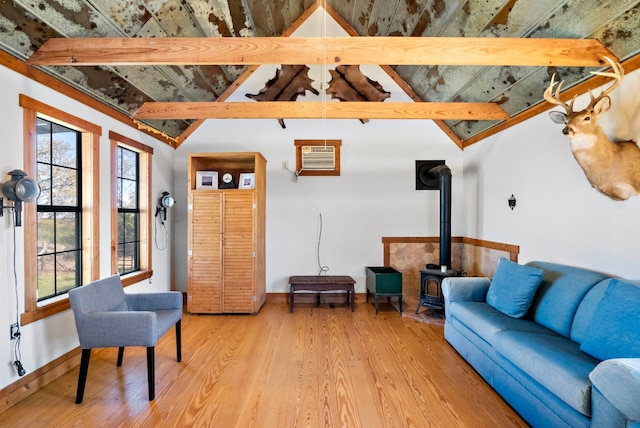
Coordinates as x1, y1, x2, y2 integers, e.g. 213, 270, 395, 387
447, 301, 555, 344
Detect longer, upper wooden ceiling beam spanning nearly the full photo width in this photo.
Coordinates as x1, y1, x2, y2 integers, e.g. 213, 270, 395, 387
27, 37, 617, 67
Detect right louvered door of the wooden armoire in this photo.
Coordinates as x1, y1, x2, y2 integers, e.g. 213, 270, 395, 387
222, 191, 255, 313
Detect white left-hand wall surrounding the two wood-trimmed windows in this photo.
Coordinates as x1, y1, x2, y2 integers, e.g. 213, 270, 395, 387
0, 66, 174, 388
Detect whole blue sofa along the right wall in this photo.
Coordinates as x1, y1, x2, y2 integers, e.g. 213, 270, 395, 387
442, 259, 640, 428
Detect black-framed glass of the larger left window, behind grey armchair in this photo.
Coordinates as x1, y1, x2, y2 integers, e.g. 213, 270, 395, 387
36, 118, 82, 302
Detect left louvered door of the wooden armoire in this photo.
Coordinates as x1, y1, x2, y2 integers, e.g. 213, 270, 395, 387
188, 192, 222, 313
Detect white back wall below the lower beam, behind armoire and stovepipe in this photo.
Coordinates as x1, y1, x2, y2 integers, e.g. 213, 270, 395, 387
172, 119, 465, 292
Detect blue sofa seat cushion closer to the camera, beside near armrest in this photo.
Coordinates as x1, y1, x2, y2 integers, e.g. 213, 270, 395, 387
493, 331, 600, 417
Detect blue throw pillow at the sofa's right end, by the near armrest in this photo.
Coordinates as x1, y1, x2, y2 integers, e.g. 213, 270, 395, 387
580, 280, 640, 360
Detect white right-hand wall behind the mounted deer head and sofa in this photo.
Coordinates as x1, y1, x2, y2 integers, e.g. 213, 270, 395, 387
464, 68, 640, 279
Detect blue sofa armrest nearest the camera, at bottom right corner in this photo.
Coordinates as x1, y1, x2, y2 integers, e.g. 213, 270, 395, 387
589, 358, 640, 421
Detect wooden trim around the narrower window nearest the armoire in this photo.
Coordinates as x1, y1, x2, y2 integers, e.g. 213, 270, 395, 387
109, 131, 153, 287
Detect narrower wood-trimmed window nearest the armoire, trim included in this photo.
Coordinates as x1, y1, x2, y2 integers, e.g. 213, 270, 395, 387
109, 132, 153, 285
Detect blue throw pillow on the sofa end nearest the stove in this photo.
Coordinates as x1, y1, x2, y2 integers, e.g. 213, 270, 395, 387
487, 257, 544, 318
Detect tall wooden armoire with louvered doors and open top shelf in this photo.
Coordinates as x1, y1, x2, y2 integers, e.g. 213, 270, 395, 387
187, 152, 267, 314
